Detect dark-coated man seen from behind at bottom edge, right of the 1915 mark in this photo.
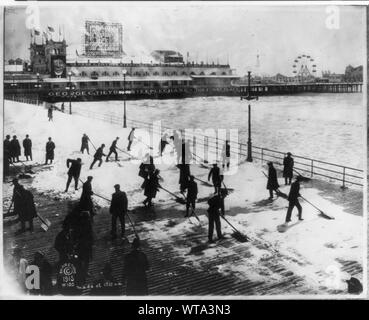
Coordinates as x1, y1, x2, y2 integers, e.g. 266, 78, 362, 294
124, 238, 150, 296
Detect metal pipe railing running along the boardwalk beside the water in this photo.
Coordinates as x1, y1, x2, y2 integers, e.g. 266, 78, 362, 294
71, 110, 364, 188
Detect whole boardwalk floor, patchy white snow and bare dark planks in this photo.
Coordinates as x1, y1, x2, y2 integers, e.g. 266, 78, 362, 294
3, 101, 364, 296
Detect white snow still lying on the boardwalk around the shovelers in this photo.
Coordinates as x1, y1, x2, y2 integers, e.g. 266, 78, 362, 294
4, 101, 364, 293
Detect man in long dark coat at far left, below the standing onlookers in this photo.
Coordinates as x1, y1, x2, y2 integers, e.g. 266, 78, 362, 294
12, 179, 37, 234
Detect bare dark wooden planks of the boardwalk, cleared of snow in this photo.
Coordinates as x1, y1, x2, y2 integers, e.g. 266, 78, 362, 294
4, 169, 363, 296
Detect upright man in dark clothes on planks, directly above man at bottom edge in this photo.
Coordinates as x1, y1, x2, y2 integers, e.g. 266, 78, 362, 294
109, 184, 128, 240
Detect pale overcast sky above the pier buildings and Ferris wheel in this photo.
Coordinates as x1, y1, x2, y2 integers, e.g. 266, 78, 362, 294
5, 2, 365, 75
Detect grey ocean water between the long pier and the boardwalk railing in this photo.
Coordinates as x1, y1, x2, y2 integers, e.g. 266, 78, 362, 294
73, 93, 366, 169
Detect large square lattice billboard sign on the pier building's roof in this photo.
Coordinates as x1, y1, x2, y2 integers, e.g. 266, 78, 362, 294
85, 21, 123, 57
